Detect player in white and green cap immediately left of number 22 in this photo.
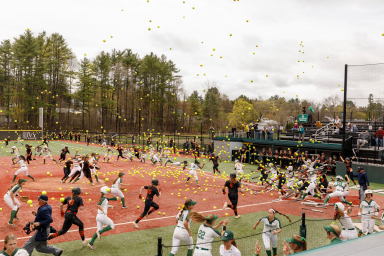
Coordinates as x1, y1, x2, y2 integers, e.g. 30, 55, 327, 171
169, 199, 196, 256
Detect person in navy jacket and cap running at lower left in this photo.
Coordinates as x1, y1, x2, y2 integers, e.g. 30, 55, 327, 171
23, 195, 63, 256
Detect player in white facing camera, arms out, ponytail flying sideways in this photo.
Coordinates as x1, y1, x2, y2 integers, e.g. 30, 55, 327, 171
253, 209, 292, 256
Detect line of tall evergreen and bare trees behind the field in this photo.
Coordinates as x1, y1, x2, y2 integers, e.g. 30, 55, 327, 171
0, 29, 383, 133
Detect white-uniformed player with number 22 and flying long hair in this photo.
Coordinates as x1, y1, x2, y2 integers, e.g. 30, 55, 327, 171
191, 212, 229, 256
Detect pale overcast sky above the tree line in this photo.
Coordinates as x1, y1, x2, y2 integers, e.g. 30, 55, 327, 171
0, 0, 384, 101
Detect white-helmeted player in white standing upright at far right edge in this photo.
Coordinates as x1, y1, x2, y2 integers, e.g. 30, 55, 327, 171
358, 189, 379, 235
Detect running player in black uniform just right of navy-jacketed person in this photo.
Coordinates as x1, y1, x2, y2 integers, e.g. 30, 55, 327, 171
48, 187, 91, 244
